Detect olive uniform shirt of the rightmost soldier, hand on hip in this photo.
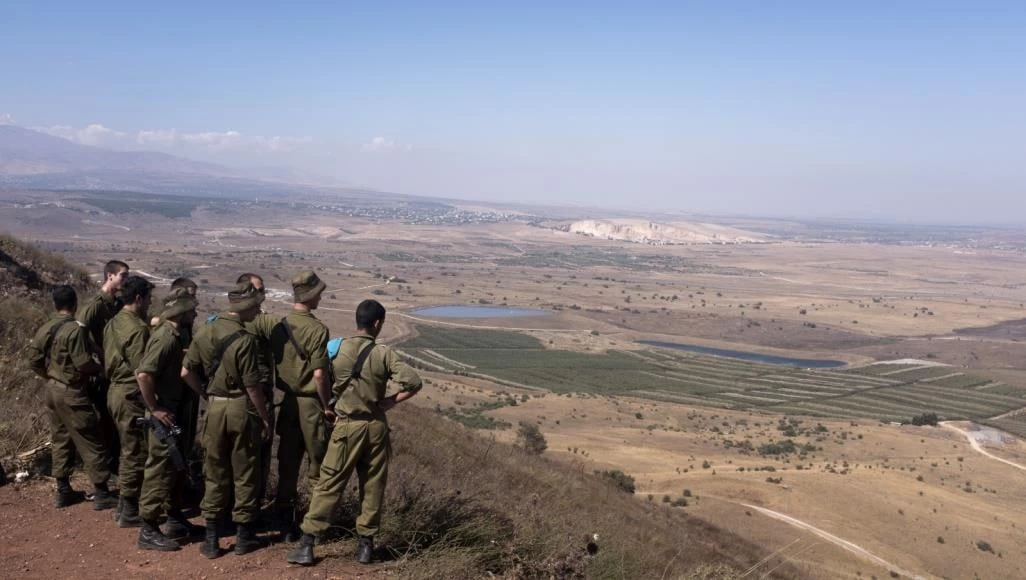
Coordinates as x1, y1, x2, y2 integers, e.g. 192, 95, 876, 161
332, 336, 423, 420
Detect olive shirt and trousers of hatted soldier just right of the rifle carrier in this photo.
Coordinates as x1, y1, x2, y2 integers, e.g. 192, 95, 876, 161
185, 313, 267, 524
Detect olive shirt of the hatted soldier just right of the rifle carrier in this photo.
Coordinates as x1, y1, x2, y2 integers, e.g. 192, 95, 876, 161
185, 313, 267, 396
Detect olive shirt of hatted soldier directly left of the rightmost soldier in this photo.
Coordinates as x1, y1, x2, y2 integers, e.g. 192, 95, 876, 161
271, 310, 328, 395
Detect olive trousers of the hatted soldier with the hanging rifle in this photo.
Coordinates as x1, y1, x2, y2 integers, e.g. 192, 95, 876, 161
139, 400, 192, 519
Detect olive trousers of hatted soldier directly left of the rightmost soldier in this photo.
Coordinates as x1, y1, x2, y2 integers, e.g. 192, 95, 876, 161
276, 393, 327, 503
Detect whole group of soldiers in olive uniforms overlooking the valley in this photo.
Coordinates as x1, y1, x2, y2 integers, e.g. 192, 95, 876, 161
29, 261, 422, 565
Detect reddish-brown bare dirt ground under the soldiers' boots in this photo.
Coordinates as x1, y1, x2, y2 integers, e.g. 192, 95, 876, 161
0, 479, 381, 580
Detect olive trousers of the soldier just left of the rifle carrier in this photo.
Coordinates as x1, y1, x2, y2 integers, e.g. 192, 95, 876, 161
107, 385, 148, 499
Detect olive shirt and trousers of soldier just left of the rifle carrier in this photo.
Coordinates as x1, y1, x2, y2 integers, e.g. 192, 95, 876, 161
104, 310, 150, 499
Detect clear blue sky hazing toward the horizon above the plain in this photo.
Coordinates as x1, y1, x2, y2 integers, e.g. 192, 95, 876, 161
0, 1, 1026, 222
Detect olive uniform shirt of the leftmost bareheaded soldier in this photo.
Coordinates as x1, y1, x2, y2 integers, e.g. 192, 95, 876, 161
27, 313, 94, 387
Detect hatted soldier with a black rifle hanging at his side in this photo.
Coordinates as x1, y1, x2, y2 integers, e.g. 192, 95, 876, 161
135, 287, 203, 551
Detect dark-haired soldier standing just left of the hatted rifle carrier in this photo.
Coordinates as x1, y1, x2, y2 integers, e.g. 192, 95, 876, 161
104, 276, 153, 528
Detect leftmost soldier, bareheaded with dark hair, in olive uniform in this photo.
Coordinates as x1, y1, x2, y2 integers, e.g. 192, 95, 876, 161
28, 285, 117, 510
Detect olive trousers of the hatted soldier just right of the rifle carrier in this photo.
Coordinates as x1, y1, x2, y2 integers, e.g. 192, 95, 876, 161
200, 395, 263, 524
